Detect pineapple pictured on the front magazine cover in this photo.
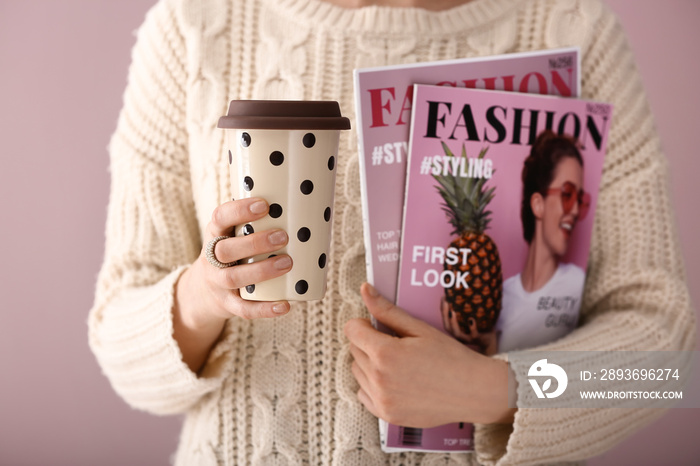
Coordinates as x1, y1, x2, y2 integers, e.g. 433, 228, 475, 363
433, 142, 503, 334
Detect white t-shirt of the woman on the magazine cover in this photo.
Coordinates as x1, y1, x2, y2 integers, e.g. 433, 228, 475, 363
496, 264, 586, 352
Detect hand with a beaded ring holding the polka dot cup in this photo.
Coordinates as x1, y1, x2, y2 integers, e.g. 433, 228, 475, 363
173, 198, 292, 372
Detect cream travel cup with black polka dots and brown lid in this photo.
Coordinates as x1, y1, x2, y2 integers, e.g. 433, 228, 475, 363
219, 100, 350, 301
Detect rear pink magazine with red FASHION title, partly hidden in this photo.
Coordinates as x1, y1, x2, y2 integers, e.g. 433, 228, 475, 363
355, 48, 580, 300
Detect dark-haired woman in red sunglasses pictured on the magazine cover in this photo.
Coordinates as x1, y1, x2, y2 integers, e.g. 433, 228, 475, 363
497, 131, 590, 352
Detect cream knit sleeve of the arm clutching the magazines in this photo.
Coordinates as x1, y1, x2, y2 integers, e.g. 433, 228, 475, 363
475, 2, 695, 465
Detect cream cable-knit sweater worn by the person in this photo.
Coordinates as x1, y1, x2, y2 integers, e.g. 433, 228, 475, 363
89, 0, 695, 466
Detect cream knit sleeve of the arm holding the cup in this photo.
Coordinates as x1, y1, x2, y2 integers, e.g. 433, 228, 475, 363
88, 1, 227, 414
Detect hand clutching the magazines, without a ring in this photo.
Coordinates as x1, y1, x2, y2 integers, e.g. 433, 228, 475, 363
345, 283, 515, 428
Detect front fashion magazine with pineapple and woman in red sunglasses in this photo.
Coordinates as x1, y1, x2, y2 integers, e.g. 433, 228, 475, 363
386, 85, 612, 451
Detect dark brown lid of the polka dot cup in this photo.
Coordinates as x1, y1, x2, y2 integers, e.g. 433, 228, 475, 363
218, 100, 350, 130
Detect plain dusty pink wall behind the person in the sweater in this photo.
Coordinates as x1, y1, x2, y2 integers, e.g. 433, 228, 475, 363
0, 0, 700, 466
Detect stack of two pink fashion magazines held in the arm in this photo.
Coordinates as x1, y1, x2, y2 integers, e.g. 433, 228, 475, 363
355, 48, 612, 452
